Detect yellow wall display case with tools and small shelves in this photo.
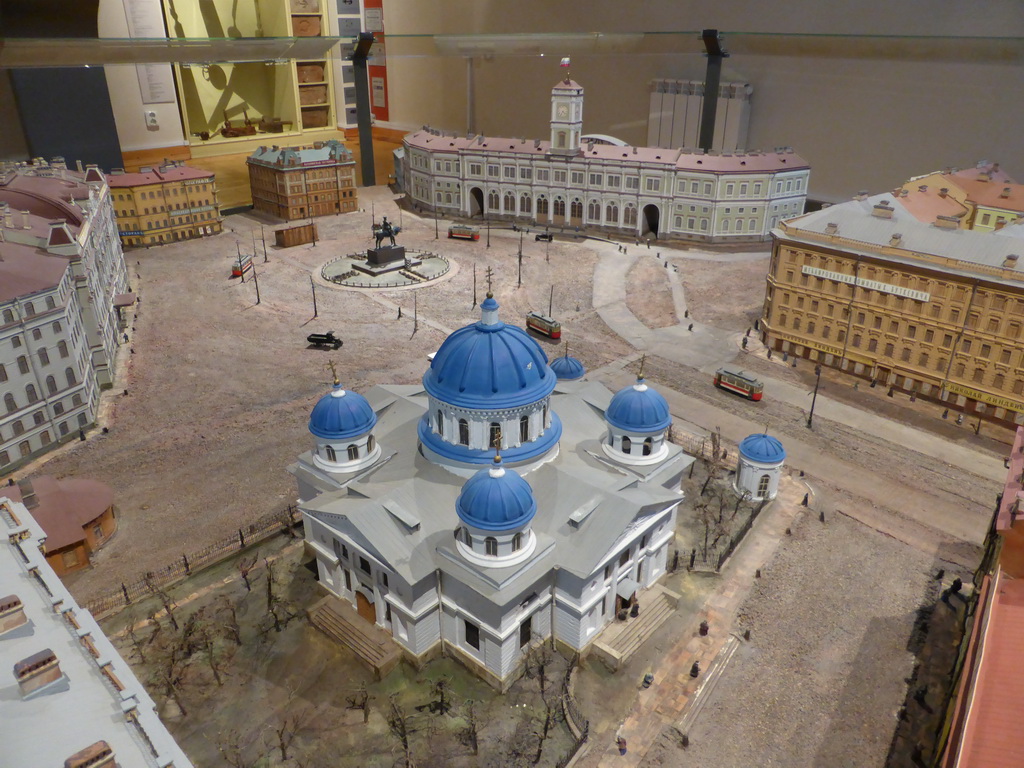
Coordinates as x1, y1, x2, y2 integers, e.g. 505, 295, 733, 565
165, 0, 334, 146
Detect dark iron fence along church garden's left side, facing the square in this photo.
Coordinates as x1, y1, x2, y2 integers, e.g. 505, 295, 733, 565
85, 504, 302, 620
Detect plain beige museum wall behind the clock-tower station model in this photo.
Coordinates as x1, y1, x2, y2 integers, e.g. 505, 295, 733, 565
385, 0, 1024, 201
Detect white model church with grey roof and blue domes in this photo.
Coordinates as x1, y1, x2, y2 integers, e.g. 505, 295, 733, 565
290, 293, 693, 687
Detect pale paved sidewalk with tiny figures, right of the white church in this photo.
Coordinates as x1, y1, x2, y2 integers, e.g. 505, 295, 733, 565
578, 478, 806, 768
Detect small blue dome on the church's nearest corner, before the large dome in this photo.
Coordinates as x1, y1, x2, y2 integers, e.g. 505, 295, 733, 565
455, 463, 537, 530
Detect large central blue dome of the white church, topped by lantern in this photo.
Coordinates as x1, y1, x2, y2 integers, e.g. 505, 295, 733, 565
423, 296, 556, 410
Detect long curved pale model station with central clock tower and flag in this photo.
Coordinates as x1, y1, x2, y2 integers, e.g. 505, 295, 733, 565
395, 71, 810, 243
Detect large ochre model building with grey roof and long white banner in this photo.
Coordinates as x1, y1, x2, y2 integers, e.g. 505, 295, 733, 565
760, 188, 1024, 424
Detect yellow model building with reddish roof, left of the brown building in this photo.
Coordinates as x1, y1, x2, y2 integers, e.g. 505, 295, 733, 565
106, 164, 221, 246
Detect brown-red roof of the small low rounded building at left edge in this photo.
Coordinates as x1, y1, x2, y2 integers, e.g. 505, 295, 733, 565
4, 475, 114, 552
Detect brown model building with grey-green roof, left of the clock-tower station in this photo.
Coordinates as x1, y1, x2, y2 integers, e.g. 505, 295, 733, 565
246, 140, 358, 221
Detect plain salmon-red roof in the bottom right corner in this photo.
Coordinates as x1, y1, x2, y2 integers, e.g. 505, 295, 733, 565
957, 571, 1024, 768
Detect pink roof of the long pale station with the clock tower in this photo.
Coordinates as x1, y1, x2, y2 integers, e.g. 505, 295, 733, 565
404, 129, 810, 173
